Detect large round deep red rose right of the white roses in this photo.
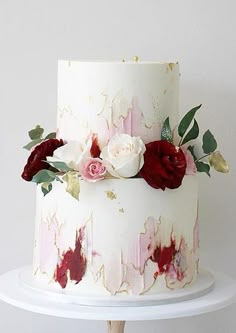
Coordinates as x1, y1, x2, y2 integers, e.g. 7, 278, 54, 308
140, 140, 186, 190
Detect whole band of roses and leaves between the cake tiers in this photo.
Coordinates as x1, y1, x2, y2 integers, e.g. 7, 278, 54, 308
22, 105, 229, 198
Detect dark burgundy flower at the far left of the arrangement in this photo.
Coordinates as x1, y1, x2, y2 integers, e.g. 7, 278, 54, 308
21, 139, 63, 181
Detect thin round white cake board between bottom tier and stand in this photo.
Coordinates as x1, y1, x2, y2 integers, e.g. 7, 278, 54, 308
21, 266, 215, 307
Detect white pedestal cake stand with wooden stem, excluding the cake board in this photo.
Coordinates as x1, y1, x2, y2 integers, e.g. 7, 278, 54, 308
0, 268, 236, 333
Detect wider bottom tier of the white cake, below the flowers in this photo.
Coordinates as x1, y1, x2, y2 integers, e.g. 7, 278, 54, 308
33, 176, 198, 296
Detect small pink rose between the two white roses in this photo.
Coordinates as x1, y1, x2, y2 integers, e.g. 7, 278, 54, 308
79, 157, 107, 182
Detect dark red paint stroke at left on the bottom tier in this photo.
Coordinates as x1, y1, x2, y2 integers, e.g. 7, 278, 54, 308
55, 229, 87, 288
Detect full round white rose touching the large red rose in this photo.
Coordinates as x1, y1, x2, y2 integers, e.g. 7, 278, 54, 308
100, 134, 146, 178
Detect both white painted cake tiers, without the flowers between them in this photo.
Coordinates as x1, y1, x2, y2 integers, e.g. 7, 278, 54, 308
29, 61, 198, 296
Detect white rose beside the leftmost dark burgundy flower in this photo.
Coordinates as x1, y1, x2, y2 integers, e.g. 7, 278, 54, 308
47, 139, 92, 171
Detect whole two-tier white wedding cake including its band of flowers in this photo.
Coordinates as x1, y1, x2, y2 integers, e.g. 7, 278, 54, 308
22, 59, 228, 297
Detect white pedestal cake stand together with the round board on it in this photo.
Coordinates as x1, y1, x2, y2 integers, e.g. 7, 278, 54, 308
0, 267, 236, 333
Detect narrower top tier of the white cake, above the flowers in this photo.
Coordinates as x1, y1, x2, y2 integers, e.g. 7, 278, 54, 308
58, 60, 179, 147
